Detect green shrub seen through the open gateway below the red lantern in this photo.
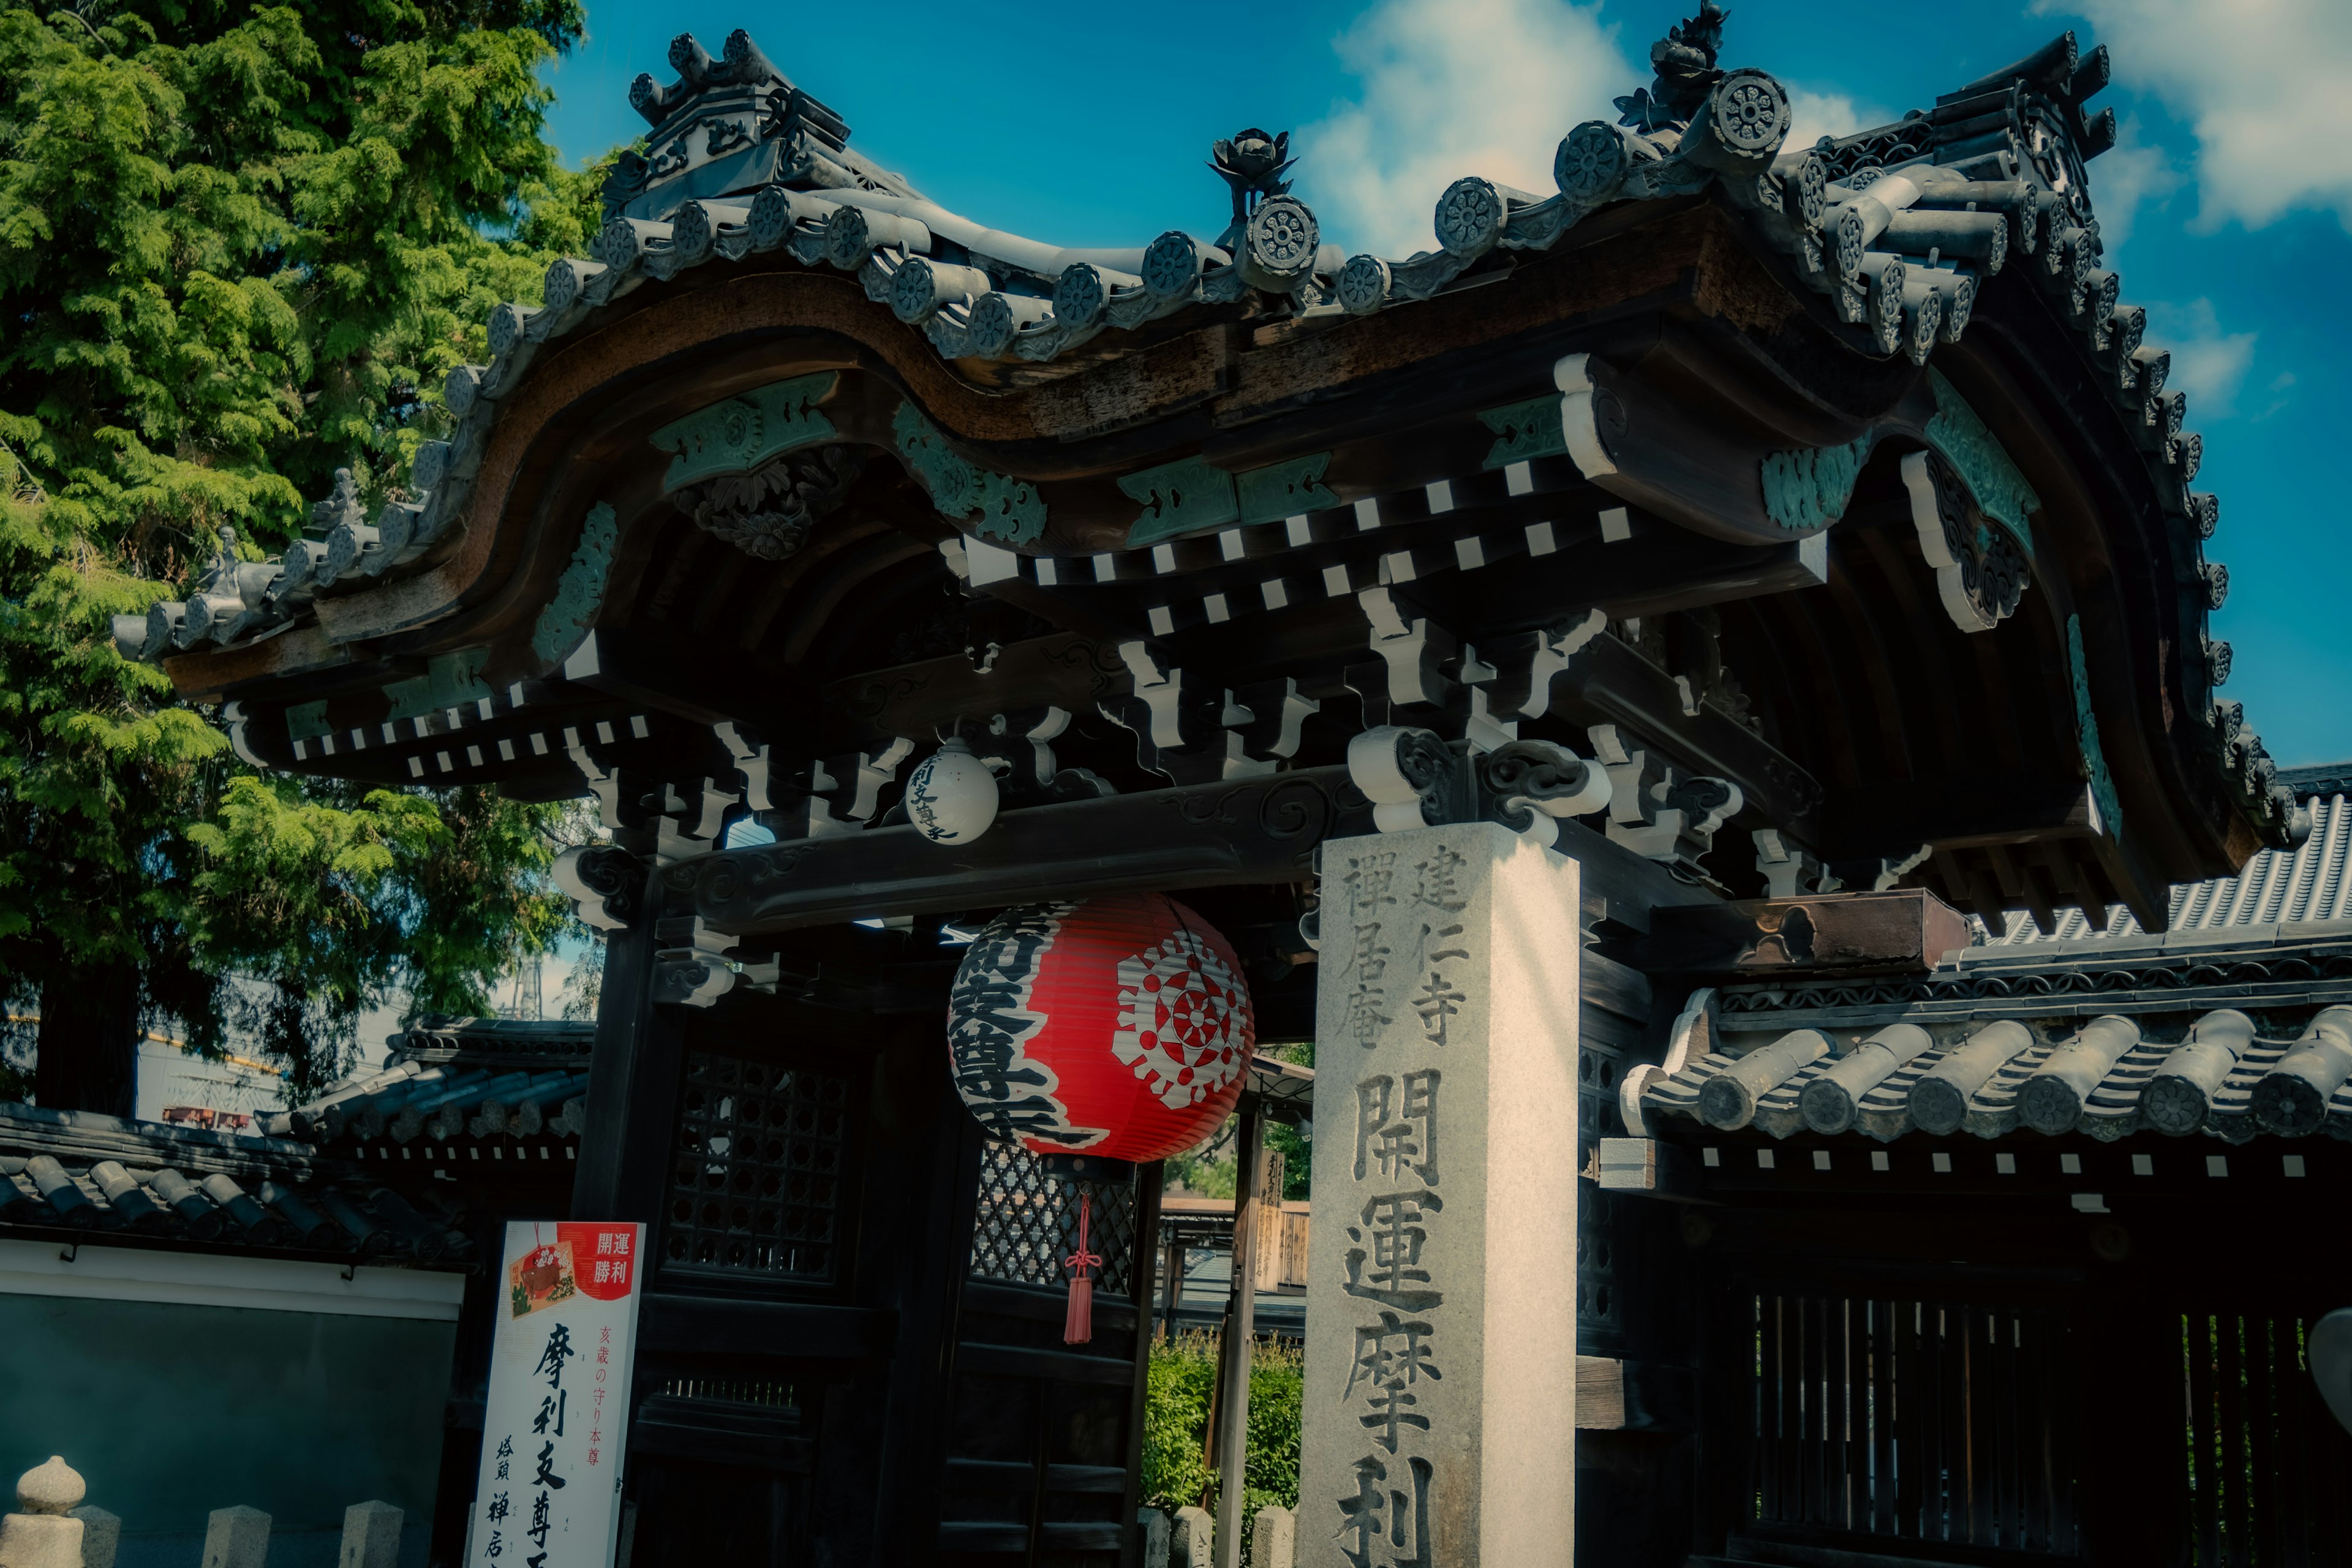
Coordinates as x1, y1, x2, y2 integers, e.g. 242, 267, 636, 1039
1143, 1329, 1305, 1540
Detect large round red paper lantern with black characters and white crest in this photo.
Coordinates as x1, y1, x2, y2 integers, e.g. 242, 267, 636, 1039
948, 893, 1258, 1161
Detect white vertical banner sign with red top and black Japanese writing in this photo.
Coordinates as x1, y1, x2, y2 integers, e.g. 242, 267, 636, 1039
468, 1220, 644, 1568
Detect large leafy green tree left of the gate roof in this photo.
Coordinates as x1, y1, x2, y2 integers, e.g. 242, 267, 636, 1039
0, 0, 600, 1112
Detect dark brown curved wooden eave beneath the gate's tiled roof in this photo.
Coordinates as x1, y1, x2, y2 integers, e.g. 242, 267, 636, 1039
167, 200, 2258, 917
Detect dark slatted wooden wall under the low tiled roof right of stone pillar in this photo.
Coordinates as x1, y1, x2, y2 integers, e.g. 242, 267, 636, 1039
1691, 1194, 2352, 1568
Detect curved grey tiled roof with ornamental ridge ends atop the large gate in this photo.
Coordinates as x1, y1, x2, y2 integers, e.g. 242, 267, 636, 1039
115, 31, 2274, 823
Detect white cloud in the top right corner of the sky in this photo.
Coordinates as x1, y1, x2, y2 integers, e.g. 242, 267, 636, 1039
2035, 0, 2352, 228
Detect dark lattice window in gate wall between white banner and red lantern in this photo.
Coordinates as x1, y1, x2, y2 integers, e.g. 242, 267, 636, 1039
663, 1051, 849, 1284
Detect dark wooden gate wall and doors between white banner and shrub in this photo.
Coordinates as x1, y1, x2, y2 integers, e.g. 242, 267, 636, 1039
567, 907, 1159, 1568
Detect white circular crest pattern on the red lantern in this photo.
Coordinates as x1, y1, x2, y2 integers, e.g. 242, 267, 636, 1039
1110, 931, 1254, 1110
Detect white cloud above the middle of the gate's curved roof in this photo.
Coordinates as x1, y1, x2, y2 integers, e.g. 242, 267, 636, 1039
1298, 0, 1649, 256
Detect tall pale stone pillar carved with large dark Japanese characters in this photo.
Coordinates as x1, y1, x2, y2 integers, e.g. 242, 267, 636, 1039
1298, 823, 1580, 1568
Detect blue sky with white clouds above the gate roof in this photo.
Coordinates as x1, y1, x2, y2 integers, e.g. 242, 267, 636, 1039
551, 0, 2352, 766
